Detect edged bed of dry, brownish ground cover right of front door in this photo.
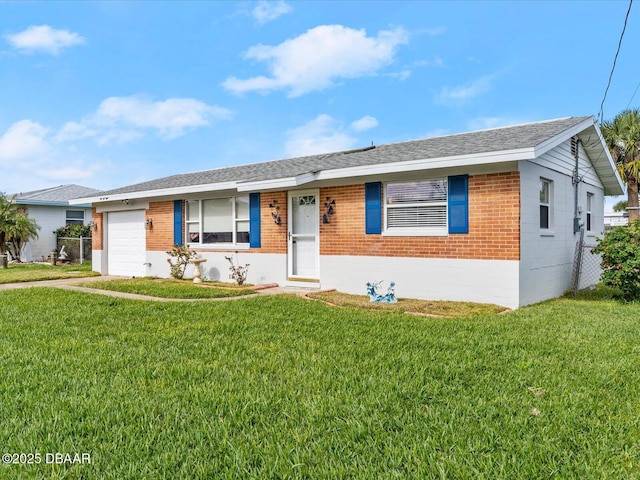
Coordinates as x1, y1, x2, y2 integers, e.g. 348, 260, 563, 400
305, 290, 505, 318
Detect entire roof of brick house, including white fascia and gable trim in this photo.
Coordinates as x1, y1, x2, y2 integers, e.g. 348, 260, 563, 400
71, 116, 622, 202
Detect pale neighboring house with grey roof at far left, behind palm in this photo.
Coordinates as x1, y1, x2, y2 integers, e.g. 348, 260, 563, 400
15, 185, 99, 262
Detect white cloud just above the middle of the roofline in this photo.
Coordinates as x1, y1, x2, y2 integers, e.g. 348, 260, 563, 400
285, 114, 357, 157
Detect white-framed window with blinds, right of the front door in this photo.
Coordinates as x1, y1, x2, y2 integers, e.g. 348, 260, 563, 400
384, 178, 447, 235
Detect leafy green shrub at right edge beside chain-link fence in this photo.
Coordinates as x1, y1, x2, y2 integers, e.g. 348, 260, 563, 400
593, 220, 640, 300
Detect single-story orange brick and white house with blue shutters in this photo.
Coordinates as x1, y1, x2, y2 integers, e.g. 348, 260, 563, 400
74, 116, 623, 308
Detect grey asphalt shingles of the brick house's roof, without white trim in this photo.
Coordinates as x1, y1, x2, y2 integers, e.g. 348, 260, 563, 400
89, 117, 591, 197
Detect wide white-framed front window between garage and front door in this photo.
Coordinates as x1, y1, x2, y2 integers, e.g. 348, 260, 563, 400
186, 195, 249, 247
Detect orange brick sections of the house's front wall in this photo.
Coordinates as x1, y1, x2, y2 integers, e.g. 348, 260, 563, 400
102, 172, 520, 260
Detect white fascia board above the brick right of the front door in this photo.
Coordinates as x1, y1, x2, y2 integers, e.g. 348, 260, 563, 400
316, 148, 534, 180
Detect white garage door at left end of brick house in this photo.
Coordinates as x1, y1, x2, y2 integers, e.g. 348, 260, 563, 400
107, 210, 147, 277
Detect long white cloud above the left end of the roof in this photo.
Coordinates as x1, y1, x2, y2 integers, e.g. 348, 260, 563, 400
56, 96, 232, 145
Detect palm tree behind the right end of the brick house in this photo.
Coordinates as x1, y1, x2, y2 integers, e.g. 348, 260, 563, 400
601, 108, 640, 222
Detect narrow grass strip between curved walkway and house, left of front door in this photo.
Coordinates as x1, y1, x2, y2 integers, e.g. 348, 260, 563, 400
80, 278, 256, 299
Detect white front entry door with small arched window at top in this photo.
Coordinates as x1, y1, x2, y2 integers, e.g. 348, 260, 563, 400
288, 190, 320, 280
